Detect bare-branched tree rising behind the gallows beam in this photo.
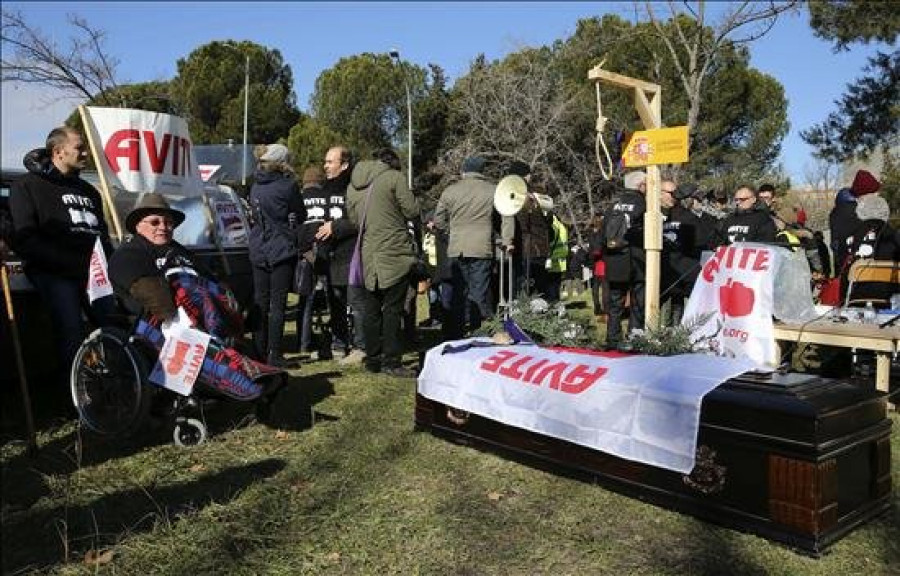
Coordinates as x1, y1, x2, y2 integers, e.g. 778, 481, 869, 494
644, 0, 800, 131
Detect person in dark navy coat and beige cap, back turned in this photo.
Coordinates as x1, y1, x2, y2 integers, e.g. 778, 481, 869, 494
250, 144, 306, 366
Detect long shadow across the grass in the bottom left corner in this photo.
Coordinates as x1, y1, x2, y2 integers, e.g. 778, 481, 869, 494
3, 459, 286, 574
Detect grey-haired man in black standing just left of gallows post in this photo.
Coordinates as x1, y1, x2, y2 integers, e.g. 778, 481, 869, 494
603, 171, 647, 348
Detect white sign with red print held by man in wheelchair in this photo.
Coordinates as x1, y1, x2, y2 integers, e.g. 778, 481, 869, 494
149, 308, 209, 396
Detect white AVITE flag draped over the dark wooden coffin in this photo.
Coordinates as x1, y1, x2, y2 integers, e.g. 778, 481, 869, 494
418, 340, 756, 473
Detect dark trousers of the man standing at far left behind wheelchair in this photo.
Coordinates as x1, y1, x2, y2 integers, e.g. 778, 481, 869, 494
29, 274, 115, 387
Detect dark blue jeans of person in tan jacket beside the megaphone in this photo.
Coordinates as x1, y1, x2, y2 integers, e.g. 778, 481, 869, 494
450, 257, 494, 338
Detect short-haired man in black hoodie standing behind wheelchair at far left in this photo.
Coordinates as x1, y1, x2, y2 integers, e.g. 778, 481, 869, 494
9, 126, 113, 392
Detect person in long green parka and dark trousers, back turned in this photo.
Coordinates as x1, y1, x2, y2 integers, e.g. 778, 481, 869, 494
347, 148, 419, 377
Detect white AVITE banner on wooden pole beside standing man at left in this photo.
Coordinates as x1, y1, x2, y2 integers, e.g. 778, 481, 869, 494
86, 106, 203, 196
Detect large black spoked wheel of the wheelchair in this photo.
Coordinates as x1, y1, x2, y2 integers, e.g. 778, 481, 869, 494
70, 328, 152, 436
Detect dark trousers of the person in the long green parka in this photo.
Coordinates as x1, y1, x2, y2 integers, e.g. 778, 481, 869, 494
363, 277, 409, 368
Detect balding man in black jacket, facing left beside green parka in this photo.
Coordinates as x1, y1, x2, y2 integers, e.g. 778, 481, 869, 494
316, 146, 366, 364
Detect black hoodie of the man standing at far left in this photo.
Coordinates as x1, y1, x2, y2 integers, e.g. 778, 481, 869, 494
9, 148, 112, 285
